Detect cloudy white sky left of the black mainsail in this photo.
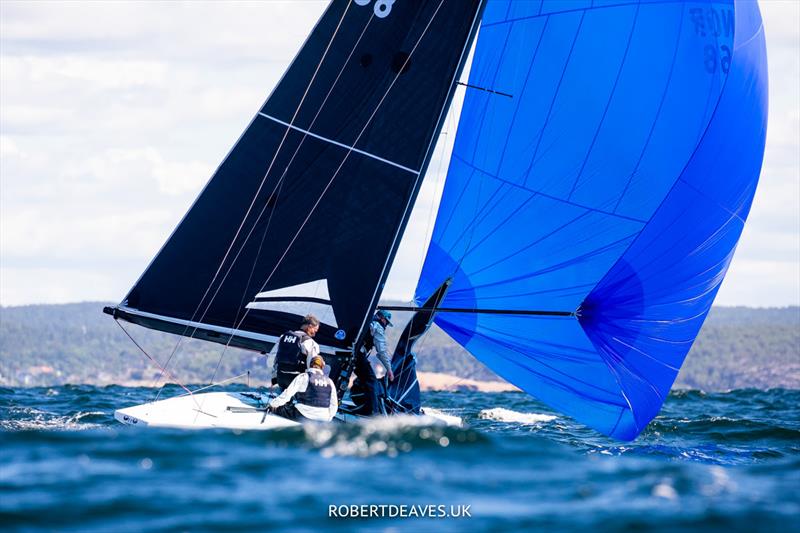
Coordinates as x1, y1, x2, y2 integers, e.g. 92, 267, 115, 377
0, 1, 326, 305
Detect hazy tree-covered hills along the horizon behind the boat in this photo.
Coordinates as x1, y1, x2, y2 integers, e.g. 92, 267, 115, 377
0, 302, 800, 390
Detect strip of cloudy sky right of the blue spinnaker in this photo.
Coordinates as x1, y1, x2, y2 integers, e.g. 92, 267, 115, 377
716, 1, 800, 306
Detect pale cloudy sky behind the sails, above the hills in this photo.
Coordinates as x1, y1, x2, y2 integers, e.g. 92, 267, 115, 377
0, 0, 800, 307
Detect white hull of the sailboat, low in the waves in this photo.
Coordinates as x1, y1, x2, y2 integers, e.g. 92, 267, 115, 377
114, 392, 462, 430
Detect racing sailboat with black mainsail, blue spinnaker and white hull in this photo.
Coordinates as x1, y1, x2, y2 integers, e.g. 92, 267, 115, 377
105, 0, 767, 440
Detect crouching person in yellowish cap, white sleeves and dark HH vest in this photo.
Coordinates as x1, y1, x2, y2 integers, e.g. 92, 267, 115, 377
269, 355, 339, 422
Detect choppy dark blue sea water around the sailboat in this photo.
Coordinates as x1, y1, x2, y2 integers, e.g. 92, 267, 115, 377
0, 386, 800, 532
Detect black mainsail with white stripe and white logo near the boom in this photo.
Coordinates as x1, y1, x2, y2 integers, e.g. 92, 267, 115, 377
106, 0, 482, 362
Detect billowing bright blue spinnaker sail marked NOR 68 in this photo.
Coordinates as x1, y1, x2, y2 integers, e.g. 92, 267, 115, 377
416, 0, 767, 440
